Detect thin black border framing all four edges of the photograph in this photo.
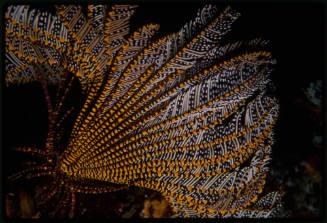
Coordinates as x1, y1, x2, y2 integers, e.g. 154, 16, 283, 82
0, 0, 327, 222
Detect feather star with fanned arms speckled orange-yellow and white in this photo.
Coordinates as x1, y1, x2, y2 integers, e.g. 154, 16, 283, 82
5, 5, 288, 217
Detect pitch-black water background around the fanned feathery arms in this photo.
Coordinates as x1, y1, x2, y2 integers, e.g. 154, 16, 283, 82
2, 3, 326, 217
